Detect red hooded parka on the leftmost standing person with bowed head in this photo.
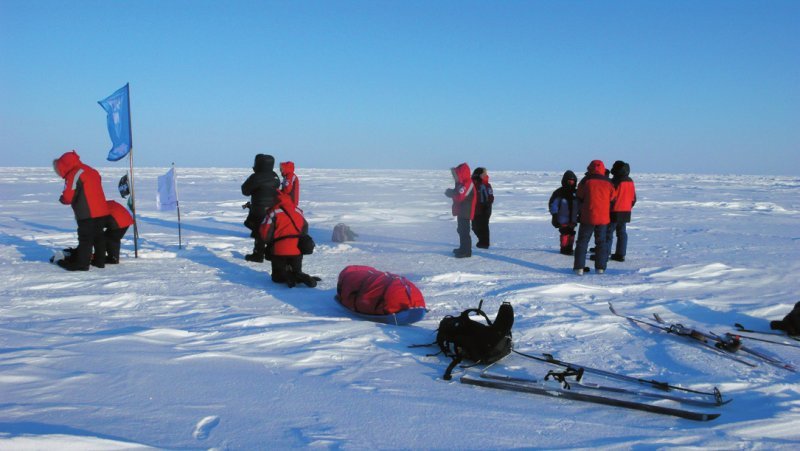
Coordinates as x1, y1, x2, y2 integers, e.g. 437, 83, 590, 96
53, 150, 108, 220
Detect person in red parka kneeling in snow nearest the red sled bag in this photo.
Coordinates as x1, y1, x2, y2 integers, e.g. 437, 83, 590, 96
259, 192, 320, 288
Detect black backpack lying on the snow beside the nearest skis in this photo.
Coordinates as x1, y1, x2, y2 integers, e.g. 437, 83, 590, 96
436, 300, 514, 381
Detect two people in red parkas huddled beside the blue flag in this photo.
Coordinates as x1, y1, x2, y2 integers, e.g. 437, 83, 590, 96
53, 150, 133, 271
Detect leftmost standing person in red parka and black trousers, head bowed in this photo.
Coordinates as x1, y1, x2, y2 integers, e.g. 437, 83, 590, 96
53, 150, 108, 271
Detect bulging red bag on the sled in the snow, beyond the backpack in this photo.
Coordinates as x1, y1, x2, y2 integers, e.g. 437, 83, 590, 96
336, 265, 425, 322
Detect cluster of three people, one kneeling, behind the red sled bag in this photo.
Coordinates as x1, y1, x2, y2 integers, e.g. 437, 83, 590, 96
242, 154, 320, 288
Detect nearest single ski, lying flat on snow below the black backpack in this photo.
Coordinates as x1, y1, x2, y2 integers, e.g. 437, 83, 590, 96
461, 375, 720, 421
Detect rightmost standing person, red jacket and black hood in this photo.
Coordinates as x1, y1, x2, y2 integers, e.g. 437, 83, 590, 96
606, 160, 636, 262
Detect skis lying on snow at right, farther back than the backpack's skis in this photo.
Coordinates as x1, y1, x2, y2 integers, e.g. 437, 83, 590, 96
608, 302, 797, 372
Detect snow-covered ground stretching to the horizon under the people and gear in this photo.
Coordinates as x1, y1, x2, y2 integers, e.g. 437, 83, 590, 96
0, 168, 800, 449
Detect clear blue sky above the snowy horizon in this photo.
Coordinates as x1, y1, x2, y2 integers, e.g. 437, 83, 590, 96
0, 0, 800, 174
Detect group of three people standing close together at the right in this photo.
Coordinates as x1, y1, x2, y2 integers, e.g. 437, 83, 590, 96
548, 160, 636, 275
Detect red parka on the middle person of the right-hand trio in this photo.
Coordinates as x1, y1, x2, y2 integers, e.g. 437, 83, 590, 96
576, 160, 616, 225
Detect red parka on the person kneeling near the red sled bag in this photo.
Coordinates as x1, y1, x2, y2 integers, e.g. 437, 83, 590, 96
259, 192, 308, 257
